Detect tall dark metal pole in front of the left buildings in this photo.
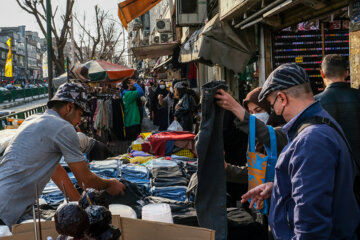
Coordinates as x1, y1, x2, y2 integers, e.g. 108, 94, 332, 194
46, 0, 53, 99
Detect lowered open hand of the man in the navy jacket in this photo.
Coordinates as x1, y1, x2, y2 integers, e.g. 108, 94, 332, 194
241, 182, 274, 208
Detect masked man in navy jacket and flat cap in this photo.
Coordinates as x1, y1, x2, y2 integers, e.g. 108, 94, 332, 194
217, 64, 360, 239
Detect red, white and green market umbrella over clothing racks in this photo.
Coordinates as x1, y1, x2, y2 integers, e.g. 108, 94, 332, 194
79, 60, 135, 81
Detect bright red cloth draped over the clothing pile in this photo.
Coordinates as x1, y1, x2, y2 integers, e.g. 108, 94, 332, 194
148, 131, 195, 156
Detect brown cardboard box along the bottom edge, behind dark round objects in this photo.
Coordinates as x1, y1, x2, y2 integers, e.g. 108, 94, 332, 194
0, 216, 215, 240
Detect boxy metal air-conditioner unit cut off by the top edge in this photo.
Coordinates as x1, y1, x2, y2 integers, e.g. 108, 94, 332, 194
176, 0, 207, 27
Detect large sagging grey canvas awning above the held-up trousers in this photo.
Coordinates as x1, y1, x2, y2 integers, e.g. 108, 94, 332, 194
180, 14, 256, 73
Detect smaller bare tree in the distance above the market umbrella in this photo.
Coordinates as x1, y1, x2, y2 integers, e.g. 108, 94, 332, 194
74, 5, 123, 63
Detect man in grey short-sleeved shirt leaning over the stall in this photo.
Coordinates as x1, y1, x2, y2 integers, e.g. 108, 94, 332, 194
0, 83, 125, 227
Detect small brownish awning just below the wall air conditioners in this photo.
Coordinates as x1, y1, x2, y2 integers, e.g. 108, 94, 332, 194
131, 42, 179, 60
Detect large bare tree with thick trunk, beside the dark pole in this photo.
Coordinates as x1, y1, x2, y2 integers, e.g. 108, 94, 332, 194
16, 0, 75, 75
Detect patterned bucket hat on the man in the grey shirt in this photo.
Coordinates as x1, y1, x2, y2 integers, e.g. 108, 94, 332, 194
47, 83, 90, 113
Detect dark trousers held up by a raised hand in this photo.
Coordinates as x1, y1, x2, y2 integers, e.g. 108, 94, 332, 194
195, 81, 227, 240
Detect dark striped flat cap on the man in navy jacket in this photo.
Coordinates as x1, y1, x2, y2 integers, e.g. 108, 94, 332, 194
259, 63, 309, 101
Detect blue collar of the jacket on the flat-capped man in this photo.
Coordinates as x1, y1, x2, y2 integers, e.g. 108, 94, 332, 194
282, 101, 322, 142
